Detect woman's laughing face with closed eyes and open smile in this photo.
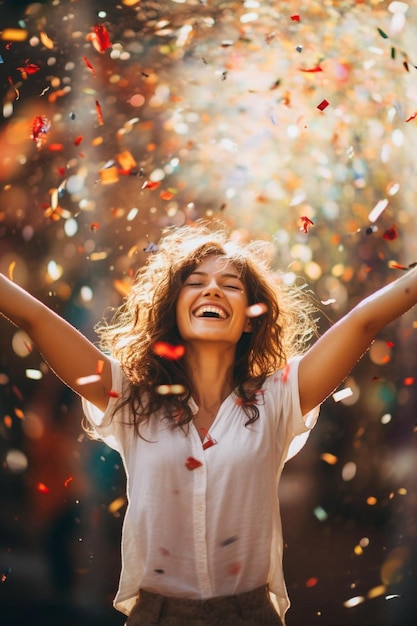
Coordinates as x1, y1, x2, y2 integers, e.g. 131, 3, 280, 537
176, 255, 250, 345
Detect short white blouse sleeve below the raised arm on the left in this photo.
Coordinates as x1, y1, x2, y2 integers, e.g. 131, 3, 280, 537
81, 359, 129, 452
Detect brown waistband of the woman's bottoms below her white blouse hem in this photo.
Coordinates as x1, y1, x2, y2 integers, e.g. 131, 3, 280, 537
138, 585, 270, 619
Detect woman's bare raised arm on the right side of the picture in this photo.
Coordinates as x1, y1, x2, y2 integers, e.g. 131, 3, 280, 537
299, 268, 417, 414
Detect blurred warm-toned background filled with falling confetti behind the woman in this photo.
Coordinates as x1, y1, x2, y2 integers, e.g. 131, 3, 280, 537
0, 0, 417, 626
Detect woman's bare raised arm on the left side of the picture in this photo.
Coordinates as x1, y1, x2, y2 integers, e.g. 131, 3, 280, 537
0, 274, 111, 410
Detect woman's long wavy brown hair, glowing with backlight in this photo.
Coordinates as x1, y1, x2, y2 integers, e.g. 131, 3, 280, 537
96, 223, 316, 436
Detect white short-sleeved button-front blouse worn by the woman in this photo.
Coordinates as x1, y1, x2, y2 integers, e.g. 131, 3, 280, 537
83, 359, 319, 620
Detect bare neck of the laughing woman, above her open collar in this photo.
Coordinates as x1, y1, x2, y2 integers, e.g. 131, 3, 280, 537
185, 344, 235, 411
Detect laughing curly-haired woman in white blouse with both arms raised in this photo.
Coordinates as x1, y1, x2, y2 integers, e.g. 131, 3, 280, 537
0, 225, 417, 626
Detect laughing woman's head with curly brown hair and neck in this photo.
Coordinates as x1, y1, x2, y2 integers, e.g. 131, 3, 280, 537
93, 222, 315, 433
